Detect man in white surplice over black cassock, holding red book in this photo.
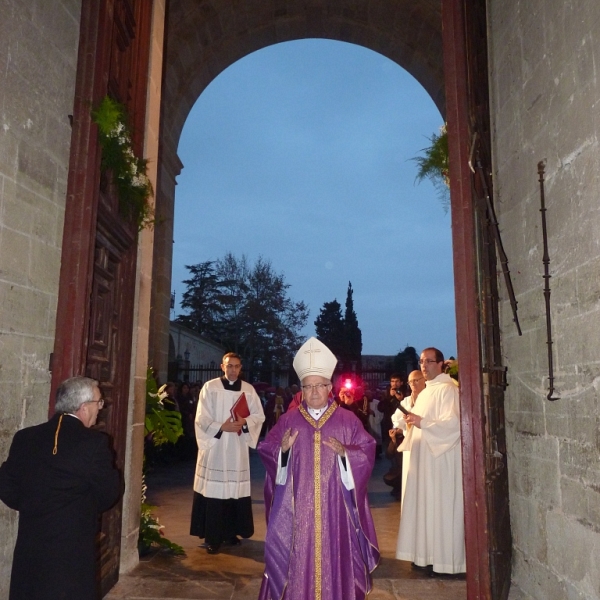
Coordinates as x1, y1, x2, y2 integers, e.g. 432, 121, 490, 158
190, 352, 265, 554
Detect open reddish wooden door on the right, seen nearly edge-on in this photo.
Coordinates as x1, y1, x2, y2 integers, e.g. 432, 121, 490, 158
442, 0, 512, 600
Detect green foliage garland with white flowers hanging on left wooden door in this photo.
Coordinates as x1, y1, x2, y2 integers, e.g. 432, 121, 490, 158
92, 96, 155, 231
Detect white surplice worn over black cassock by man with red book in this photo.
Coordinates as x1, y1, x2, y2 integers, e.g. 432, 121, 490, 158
194, 379, 265, 499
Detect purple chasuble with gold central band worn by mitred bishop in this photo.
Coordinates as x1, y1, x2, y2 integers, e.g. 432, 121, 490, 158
258, 402, 379, 600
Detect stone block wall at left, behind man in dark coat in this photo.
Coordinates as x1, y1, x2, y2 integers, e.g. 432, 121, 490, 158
0, 0, 80, 598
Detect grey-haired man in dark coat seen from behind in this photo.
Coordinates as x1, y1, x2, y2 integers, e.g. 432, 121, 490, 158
0, 377, 122, 600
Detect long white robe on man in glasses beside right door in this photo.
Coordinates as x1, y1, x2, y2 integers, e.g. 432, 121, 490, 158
396, 374, 466, 573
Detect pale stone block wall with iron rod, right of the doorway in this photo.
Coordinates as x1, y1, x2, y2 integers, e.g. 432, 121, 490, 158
488, 0, 600, 600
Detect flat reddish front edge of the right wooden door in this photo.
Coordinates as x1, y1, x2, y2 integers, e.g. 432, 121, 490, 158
442, 0, 491, 600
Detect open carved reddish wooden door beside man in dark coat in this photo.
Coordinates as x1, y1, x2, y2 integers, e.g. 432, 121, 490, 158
51, 0, 152, 594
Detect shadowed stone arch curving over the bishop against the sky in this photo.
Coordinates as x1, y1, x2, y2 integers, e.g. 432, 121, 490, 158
150, 0, 445, 377
